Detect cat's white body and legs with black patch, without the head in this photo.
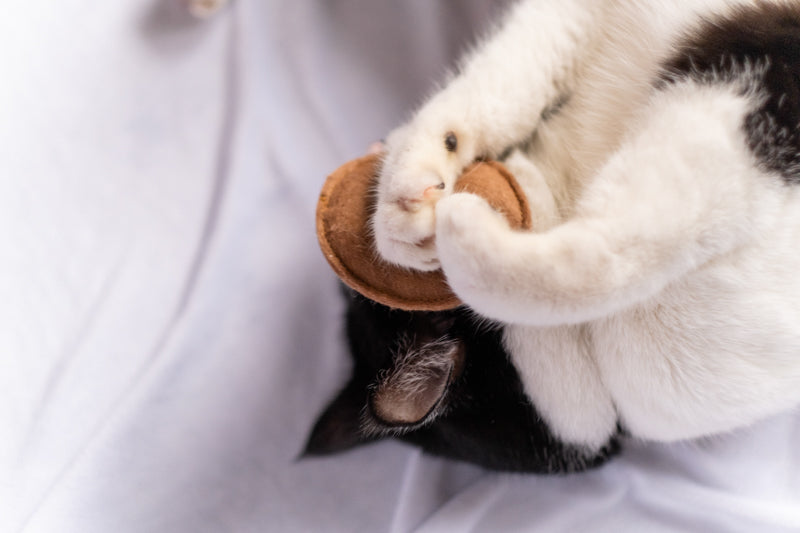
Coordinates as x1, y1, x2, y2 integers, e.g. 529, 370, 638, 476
372, 0, 800, 451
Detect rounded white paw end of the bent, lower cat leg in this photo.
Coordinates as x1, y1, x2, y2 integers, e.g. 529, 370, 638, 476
436, 193, 511, 300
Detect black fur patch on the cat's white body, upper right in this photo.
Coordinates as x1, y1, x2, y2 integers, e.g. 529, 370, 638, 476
658, 3, 800, 184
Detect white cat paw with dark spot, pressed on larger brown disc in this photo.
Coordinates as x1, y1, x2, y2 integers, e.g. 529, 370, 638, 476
372, 117, 474, 270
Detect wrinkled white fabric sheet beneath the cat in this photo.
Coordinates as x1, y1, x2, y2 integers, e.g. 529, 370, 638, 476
0, 0, 800, 533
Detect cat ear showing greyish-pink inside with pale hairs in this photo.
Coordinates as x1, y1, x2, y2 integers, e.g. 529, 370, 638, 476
364, 339, 464, 434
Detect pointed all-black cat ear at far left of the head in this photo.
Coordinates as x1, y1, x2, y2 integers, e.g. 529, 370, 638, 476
300, 381, 377, 458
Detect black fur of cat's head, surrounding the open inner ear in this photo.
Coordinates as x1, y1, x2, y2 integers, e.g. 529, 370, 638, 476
306, 292, 618, 473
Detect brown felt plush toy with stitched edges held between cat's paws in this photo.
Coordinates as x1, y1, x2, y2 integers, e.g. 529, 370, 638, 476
317, 154, 531, 311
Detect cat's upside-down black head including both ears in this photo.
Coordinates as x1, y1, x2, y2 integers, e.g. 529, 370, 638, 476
304, 290, 616, 473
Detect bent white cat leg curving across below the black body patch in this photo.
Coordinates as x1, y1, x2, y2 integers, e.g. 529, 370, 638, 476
436, 83, 768, 326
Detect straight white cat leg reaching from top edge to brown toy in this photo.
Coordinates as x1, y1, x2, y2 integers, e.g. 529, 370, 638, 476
372, 0, 602, 270
